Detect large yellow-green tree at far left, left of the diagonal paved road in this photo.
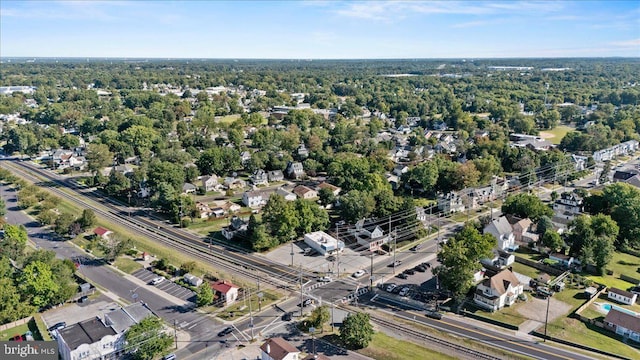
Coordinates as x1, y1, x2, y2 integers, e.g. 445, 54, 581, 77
18, 261, 60, 307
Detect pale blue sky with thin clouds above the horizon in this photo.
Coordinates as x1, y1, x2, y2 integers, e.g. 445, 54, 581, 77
0, 0, 640, 59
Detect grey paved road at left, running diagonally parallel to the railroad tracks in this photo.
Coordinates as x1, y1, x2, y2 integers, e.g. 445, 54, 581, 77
0, 186, 224, 358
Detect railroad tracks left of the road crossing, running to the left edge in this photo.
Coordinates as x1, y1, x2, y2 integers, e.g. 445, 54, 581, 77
2, 161, 312, 290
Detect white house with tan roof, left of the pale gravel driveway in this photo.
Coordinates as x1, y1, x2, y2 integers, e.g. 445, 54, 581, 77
473, 269, 524, 311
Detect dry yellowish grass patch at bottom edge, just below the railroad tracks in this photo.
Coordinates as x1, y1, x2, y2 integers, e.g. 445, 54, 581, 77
358, 331, 456, 360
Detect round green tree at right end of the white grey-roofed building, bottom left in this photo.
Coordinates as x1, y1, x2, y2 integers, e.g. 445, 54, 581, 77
125, 316, 173, 360
